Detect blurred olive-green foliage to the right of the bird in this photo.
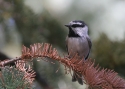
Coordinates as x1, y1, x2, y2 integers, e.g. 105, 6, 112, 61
92, 34, 125, 75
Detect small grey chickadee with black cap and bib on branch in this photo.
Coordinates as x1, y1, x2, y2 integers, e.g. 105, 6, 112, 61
65, 20, 92, 85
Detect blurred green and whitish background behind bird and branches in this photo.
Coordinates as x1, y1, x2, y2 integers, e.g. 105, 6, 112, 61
0, 0, 125, 89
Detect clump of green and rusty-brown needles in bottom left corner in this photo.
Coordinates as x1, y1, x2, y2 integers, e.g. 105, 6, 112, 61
0, 60, 35, 89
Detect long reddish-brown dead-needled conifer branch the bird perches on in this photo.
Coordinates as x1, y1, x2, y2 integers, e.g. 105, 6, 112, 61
0, 43, 125, 89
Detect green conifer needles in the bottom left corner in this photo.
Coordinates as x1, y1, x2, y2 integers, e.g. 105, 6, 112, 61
0, 67, 31, 89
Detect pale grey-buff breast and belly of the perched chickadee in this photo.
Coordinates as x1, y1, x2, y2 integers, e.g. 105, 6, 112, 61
67, 37, 89, 58
